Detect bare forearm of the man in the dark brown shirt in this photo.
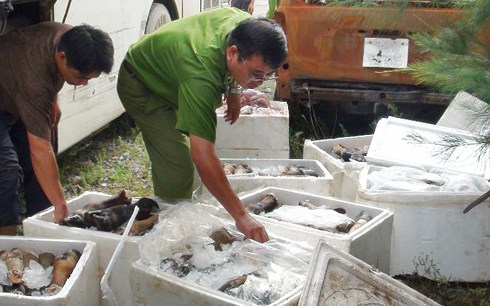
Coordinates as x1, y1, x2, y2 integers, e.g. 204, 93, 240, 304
27, 132, 68, 223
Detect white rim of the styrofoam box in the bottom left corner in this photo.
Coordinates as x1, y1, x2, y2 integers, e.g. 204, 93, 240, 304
0, 236, 98, 305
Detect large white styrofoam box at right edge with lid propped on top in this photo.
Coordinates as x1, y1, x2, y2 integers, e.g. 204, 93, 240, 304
356, 117, 490, 282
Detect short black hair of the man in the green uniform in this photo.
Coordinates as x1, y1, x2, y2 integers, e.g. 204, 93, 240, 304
227, 17, 288, 69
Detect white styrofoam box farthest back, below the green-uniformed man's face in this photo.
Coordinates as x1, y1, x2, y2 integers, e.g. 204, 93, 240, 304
214, 101, 289, 158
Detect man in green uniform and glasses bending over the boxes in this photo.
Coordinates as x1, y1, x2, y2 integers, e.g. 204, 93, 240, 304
118, 8, 287, 242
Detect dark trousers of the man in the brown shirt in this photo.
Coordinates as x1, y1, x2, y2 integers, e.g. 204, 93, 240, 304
0, 112, 51, 226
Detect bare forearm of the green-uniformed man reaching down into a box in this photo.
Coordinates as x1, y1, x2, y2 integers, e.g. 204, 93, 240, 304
190, 134, 269, 242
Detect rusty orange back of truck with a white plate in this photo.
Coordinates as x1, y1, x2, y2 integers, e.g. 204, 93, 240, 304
274, 0, 470, 115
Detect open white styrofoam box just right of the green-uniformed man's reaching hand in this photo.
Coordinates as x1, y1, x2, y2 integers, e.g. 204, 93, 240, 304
240, 187, 393, 272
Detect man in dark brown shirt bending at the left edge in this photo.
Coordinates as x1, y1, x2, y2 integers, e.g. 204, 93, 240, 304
0, 22, 114, 235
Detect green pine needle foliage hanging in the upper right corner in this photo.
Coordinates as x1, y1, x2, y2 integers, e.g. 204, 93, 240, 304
408, 0, 490, 103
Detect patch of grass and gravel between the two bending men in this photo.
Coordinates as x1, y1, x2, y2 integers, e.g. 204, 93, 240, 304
58, 115, 153, 197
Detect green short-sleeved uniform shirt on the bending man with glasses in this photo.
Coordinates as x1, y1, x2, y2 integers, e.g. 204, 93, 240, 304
126, 8, 251, 143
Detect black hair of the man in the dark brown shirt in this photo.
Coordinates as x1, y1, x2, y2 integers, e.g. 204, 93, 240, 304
58, 24, 114, 75
